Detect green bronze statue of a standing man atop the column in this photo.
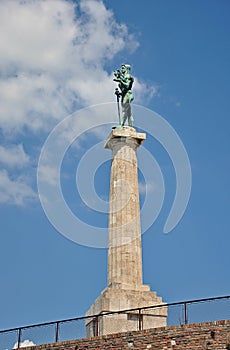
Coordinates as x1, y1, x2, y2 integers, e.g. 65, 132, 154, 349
113, 64, 134, 126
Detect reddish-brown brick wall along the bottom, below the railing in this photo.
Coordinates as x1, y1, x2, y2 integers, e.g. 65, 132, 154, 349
26, 321, 230, 350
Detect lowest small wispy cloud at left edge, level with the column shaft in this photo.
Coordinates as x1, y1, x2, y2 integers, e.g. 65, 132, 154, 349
0, 169, 37, 205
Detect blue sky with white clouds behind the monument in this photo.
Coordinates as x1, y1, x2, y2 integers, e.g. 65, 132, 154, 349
0, 0, 230, 329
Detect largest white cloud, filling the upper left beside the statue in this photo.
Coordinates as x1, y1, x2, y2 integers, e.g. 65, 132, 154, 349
0, 0, 140, 131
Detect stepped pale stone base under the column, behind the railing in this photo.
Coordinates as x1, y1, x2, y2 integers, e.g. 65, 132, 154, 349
86, 284, 167, 337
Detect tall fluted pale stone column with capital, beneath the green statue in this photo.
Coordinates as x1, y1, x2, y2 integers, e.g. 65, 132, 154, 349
105, 127, 146, 290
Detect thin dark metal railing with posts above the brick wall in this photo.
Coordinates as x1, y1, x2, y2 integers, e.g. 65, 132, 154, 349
0, 295, 230, 350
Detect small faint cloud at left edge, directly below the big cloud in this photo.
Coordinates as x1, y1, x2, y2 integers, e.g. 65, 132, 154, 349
0, 144, 29, 167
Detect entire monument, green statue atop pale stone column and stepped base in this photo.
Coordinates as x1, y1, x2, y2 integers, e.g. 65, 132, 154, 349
86, 65, 167, 337
